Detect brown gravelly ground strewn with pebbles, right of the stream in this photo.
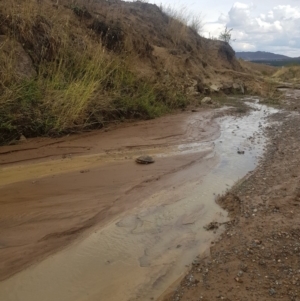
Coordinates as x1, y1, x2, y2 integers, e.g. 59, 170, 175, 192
164, 90, 300, 301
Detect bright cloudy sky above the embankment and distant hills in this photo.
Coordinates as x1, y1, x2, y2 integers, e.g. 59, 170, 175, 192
135, 0, 300, 57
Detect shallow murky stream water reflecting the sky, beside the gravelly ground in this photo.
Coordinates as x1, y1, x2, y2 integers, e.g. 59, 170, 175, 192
0, 102, 276, 301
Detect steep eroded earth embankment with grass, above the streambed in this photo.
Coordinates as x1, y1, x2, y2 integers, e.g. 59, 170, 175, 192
0, 0, 255, 144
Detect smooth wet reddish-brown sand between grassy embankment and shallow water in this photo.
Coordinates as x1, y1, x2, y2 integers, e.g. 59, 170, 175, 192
0, 111, 220, 280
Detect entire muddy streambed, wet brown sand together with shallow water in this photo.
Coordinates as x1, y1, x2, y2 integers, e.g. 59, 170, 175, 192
0, 99, 275, 301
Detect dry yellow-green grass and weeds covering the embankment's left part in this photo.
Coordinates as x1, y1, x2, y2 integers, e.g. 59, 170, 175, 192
0, 0, 186, 144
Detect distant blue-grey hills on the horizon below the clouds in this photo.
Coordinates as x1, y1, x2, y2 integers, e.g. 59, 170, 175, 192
235, 51, 300, 66
